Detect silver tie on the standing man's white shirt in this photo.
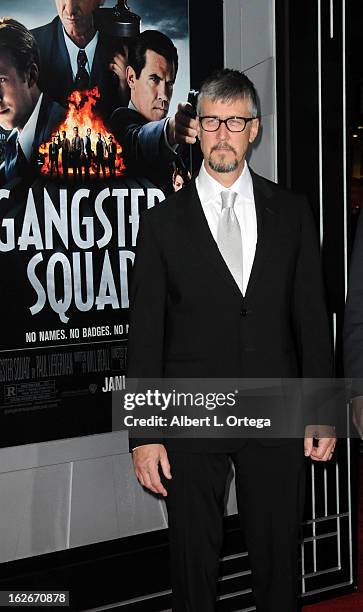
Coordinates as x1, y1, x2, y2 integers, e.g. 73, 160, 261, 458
217, 191, 243, 292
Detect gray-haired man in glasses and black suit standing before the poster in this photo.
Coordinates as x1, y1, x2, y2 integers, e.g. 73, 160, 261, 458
128, 69, 335, 612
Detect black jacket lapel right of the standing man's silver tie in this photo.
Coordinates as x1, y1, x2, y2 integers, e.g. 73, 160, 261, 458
245, 170, 278, 298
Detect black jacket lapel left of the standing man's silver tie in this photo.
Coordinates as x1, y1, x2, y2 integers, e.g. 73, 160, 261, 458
181, 180, 243, 300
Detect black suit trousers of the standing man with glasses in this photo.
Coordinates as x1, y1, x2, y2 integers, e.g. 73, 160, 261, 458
164, 440, 305, 612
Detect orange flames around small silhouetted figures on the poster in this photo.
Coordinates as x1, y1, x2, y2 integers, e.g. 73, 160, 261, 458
39, 87, 126, 177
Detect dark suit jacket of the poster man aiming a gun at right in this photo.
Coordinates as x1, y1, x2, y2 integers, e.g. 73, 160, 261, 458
111, 108, 179, 193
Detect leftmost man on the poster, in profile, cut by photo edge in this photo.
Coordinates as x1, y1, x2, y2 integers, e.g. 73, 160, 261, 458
0, 18, 65, 184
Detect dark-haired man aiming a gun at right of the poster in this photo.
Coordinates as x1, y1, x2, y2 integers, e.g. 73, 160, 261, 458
111, 30, 186, 192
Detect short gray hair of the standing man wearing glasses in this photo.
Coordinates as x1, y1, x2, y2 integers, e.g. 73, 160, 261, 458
197, 68, 258, 117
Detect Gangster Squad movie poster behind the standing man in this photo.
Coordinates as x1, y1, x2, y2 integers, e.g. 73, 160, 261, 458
0, 0, 189, 446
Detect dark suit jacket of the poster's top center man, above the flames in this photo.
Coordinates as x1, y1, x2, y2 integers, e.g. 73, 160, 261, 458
32, 17, 119, 117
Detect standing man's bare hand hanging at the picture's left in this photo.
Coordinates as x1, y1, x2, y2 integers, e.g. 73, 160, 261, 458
132, 444, 171, 497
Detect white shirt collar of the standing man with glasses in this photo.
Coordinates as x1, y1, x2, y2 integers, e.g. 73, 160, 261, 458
196, 161, 254, 203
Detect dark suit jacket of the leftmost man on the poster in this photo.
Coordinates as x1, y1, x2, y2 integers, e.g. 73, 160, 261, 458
0, 93, 66, 184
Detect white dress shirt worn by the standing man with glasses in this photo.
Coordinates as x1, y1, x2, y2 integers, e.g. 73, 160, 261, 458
195, 162, 257, 295
